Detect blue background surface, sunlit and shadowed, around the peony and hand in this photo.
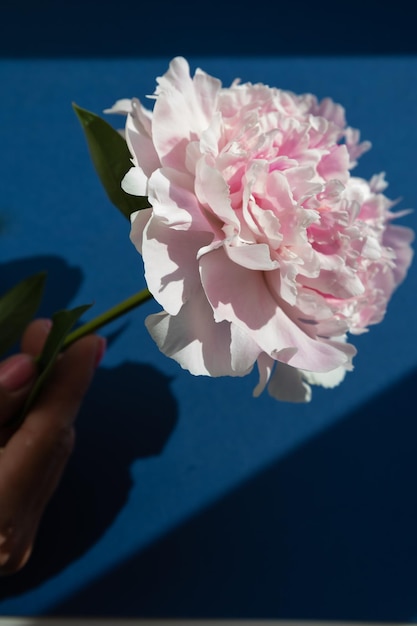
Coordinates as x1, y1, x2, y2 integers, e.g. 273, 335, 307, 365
0, 0, 417, 621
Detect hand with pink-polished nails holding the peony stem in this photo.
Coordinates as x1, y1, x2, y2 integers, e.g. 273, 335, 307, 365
0, 319, 105, 575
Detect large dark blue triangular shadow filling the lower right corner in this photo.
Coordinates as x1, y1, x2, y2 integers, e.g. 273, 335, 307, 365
49, 372, 417, 621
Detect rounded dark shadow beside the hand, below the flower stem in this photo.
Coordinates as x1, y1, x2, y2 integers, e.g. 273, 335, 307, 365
0, 363, 177, 598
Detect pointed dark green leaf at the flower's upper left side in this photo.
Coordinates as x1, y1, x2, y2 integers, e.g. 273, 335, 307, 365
72, 103, 150, 219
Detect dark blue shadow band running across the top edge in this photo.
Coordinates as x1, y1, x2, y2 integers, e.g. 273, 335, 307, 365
0, 0, 417, 58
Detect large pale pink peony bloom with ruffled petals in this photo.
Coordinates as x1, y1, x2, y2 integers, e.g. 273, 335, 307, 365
106, 57, 413, 401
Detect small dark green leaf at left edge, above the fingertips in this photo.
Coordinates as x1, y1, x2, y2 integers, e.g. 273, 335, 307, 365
0, 272, 46, 356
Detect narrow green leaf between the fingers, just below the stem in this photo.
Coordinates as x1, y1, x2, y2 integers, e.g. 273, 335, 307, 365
15, 304, 92, 425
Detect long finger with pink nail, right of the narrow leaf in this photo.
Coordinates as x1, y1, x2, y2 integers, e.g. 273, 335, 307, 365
0, 333, 105, 573
